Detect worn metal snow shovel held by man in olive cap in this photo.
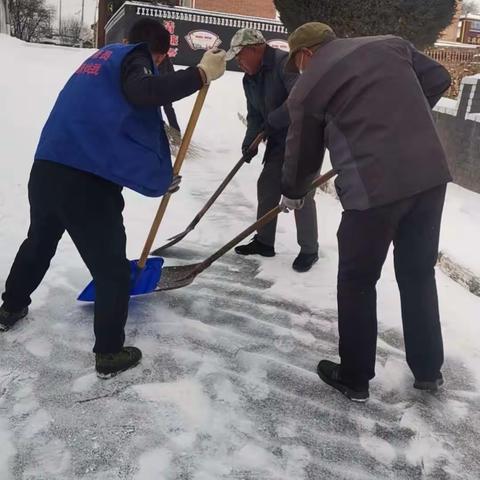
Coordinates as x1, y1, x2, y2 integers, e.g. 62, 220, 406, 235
155, 170, 336, 292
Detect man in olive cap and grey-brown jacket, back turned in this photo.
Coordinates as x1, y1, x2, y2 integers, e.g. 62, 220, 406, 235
282, 23, 451, 401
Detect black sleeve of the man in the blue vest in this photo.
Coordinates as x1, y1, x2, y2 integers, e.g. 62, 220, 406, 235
121, 47, 203, 107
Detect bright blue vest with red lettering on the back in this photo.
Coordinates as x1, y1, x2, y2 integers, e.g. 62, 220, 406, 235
35, 44, 172, 197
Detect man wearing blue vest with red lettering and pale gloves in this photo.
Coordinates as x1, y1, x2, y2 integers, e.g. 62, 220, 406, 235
0, 18, 226, 378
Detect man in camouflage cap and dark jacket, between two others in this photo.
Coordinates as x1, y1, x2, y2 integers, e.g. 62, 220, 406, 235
227, 28, 318, 272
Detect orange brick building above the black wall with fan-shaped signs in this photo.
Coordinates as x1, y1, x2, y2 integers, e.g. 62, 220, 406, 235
178, 0, 277, 18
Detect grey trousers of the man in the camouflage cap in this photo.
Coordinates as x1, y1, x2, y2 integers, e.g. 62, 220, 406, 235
256, 147, 318, 253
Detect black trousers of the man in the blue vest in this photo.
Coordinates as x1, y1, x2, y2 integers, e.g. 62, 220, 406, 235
2, 161, 130, 353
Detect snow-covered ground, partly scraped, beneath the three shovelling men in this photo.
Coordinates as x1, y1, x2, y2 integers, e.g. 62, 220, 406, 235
0, 35, 480, 480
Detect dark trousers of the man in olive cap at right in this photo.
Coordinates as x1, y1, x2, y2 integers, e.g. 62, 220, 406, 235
338, 185, 446, 386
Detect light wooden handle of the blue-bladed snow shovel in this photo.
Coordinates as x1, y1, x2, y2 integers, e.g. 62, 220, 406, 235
137, 85, 208, 269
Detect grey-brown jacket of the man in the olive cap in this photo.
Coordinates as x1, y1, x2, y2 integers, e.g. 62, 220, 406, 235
282, 36, 451, 210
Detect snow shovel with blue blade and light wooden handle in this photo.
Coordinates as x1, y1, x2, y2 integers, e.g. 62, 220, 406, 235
78, 85, 208, 302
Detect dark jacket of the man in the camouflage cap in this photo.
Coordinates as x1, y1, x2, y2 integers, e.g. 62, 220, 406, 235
242, 45, 298, 156
